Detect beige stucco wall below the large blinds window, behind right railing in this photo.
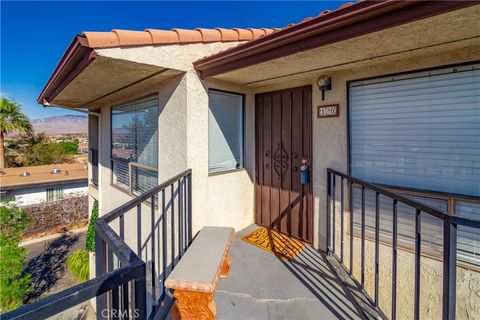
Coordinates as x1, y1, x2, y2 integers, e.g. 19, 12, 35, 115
335, 222, 480, 320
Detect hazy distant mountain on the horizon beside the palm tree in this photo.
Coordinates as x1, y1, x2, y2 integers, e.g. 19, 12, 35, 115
31, 115, 88, 135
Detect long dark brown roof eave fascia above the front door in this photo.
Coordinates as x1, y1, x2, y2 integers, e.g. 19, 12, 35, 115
193, 0, 480, 78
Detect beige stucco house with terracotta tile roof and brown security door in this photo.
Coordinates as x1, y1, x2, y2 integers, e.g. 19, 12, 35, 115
9, 1, 480, 319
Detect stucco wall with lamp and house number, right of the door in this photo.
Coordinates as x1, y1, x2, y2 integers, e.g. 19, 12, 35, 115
251, 43, 480, 250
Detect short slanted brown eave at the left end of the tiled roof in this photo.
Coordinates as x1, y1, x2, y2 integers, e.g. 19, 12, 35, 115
37, 35, 96, 106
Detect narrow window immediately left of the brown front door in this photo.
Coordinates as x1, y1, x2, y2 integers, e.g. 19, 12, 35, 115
208, 90, 244, 173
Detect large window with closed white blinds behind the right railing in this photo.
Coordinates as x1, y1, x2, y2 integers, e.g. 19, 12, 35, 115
349, 64, 480, 264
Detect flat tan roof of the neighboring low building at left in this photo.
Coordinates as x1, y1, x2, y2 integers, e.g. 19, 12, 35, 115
0, 162, 88, 190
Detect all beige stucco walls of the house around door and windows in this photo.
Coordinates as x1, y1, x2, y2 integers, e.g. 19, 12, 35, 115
82, 19, 480, 319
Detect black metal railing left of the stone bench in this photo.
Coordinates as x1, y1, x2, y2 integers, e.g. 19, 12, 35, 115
2, 169, 192, 320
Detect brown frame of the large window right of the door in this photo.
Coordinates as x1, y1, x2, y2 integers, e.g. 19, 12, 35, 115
345, 61, 480, 271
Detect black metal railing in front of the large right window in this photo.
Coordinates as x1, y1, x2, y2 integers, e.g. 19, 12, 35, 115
327, 169, 480, 320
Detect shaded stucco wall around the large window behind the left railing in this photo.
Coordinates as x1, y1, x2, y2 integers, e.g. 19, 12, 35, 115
92, 75, 187, 308
